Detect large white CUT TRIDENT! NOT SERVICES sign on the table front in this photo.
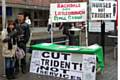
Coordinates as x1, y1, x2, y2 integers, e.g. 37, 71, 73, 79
30, 50, 96, 80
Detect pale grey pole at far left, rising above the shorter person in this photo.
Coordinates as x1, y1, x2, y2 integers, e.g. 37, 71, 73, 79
2, 0, 6, 29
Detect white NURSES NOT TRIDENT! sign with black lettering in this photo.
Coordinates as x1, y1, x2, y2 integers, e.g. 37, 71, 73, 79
90, 1, 116, 20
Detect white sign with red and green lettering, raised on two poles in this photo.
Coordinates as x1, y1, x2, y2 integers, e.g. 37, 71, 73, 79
50, 2, 87, 23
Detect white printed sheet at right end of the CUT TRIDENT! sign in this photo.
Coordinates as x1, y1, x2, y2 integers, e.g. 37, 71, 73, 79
83, 55, 96, 80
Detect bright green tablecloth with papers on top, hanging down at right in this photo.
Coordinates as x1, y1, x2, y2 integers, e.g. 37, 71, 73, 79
31, 43, 104, 71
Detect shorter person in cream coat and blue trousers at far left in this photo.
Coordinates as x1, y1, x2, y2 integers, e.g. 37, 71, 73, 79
2, 20, 17, 80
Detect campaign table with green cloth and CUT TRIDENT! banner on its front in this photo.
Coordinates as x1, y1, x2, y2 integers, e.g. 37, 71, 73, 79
30, 43, 104, 80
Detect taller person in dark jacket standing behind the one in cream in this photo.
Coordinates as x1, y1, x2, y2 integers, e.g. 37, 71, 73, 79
15, 13, 30, 73
